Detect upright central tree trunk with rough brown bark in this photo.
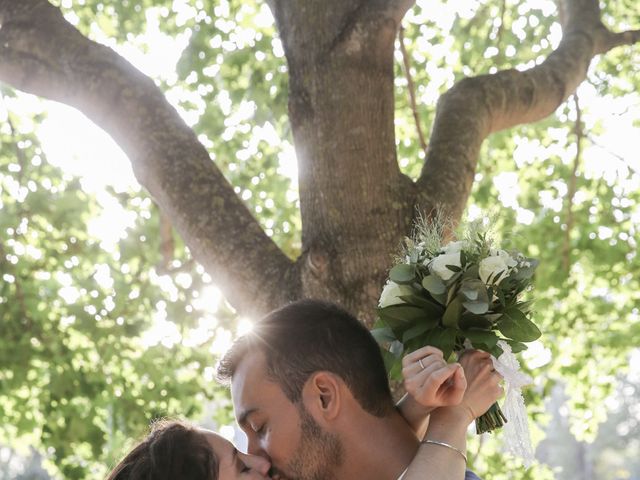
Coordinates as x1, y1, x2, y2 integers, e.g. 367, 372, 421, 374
271, 0, 413, 320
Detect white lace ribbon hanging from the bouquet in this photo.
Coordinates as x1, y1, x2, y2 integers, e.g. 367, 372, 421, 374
491, 340, 534, 468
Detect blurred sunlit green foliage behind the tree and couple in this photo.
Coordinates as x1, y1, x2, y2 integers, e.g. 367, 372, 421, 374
0, 0, 640, 480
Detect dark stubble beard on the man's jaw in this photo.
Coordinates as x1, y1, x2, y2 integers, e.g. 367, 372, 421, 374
287, 405, 344, 480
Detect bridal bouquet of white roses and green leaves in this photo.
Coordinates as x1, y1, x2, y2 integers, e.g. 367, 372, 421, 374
373, 219, 540, 437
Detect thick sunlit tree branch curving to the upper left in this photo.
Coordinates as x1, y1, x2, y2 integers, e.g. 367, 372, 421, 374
0, 0, 300, 314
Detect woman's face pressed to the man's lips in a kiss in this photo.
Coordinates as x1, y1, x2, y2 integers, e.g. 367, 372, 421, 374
203, 430, 271, 480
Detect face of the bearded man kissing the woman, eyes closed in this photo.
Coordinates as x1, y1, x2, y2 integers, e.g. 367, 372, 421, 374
231, 352, 342, 480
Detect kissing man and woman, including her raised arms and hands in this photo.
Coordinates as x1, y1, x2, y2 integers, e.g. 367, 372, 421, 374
108, 300, 503, 480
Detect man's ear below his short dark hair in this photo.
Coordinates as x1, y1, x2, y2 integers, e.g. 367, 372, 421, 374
302, 372, 343, 420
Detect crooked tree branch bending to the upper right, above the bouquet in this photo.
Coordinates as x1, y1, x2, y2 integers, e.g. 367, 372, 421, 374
417, 0, 638, 220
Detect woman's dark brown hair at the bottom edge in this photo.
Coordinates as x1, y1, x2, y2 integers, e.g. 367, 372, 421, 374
107, 420, 218, 480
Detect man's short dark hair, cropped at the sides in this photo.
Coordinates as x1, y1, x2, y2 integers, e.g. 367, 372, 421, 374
218, 300, 393, 417
